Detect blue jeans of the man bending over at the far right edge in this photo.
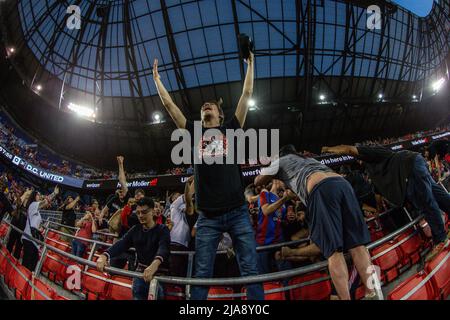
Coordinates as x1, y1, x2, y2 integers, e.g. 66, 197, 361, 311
406, 155, 450, 243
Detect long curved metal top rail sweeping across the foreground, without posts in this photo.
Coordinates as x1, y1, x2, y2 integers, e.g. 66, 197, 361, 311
0, 211, 422, 286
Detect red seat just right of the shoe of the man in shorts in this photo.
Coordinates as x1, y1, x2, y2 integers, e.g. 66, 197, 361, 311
388, 272, 436, 300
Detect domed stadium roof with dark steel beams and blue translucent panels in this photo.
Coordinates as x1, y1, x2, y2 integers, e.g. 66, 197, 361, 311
0, 0, 450, 169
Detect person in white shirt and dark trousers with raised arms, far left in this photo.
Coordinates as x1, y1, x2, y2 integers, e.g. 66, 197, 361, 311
22, 186, 59, 272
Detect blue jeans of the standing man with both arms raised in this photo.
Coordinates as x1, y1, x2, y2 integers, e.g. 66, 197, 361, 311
191, 205, 264, 300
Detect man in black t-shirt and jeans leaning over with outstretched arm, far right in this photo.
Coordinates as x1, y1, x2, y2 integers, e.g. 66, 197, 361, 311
322, 145, 450, 261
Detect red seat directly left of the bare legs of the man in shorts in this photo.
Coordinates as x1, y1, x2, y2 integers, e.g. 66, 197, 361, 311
289, 272, 331, 300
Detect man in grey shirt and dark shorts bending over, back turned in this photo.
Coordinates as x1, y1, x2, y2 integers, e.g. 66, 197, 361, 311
255, 145, 382, 300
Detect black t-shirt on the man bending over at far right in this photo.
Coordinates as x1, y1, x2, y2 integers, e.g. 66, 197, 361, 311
358, 147, 419, 206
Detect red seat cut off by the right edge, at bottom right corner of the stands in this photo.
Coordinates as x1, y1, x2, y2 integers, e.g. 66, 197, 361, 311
425, 250, 450, 300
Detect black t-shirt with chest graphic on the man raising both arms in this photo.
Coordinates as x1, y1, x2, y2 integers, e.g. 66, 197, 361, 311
186, 117, 245, 216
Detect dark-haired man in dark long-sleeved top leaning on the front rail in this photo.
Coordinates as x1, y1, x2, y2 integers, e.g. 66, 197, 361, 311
97, 197, 170, 300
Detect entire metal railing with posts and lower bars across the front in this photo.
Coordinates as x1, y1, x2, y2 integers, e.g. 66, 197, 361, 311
0, 205, 432, 299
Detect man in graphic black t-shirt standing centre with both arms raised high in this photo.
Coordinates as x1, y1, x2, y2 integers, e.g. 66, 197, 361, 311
153, 54, 264, 300
